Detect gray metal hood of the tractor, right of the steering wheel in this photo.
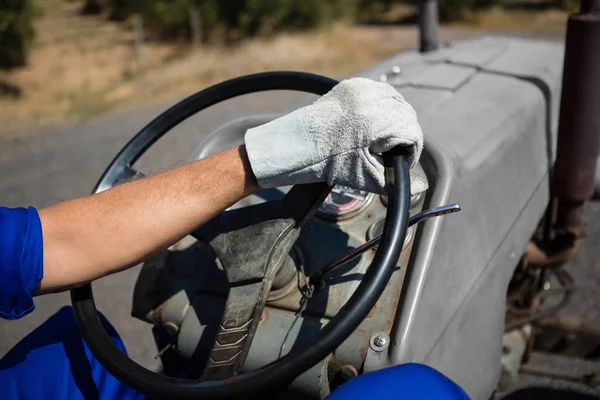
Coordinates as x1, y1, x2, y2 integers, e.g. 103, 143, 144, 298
356, 38, 563, 399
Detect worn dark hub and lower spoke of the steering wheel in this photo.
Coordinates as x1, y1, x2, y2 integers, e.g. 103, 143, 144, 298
194, 184, 330, 380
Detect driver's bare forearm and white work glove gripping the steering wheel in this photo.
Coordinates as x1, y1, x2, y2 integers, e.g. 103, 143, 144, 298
36, 78, 423, 294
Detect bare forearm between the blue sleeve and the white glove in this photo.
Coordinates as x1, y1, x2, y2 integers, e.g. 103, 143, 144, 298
36, 147, 259, 294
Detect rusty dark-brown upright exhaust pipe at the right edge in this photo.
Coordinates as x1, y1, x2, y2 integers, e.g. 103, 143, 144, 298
553, 1, 600, 239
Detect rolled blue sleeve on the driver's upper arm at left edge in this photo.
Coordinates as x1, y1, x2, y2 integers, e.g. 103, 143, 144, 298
0, 207, 44, 319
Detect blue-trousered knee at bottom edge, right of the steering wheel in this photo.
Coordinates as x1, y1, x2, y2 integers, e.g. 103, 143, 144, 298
327, 363, 469, 400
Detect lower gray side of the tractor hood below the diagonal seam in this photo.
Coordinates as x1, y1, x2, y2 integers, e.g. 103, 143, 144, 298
422, 180, 548, 399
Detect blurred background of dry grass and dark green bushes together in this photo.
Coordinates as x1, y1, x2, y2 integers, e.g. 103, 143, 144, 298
0, 0, 578, 138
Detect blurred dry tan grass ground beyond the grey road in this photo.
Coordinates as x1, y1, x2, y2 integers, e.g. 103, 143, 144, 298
0, 0, 567, 137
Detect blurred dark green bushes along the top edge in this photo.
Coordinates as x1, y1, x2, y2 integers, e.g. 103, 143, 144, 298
0, 0, 577, 68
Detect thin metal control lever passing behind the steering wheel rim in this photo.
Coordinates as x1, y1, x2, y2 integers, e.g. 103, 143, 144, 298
309, 203, 461, 289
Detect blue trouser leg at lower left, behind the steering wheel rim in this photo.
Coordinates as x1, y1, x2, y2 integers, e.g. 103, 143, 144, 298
0, 307, 144, 400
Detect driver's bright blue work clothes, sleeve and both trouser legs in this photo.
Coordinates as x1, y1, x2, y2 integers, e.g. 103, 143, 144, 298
0, 207, 468, 400
